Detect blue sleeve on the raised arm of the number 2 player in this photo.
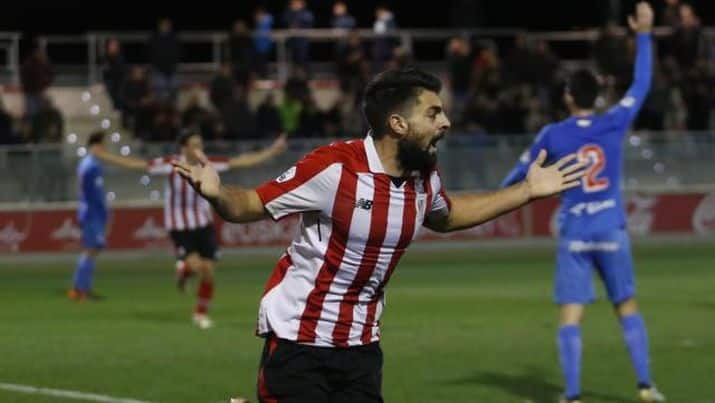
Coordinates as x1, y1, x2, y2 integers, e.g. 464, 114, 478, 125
609, 33, 653, 125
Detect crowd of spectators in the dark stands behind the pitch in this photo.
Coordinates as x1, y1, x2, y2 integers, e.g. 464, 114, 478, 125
0, 0, 715, 143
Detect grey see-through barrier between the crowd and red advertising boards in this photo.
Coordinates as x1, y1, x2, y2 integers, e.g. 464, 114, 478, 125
0, 132, 715, 205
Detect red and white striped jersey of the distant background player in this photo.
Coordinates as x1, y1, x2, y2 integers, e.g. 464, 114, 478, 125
148, 155, 228, 231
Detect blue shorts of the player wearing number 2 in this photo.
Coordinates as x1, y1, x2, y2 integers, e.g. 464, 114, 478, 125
554, 229, 635, 304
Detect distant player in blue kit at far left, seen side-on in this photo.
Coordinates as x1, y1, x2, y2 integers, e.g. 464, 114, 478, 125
68, 132, 109, 301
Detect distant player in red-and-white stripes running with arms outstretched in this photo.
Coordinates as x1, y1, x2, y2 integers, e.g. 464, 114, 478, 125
97, 131, 286, 329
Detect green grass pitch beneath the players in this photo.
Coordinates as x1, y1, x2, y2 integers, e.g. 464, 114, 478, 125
0, 244, 715, 403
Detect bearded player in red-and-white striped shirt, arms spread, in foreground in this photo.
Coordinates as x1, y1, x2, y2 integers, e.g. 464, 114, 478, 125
174, 69, 584, 403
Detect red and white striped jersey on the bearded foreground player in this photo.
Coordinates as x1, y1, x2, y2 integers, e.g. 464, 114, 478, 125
256, 136, 450, 347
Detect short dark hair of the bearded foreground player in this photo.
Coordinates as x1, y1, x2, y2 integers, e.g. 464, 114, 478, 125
362, 68, 442, 138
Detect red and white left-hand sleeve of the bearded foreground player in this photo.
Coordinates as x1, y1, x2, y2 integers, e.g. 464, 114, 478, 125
256, 146, 342, 220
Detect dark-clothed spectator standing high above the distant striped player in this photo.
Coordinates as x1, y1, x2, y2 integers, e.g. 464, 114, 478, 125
149, 18, 181, 101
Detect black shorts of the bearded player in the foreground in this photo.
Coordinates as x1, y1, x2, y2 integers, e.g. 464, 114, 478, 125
258, 337, 383, 403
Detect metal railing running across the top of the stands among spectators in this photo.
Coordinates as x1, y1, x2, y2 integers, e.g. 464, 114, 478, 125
19, 27, 715, 84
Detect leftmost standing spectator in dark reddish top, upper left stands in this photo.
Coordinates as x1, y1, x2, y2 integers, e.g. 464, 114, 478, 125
20, 46, 55, 120
